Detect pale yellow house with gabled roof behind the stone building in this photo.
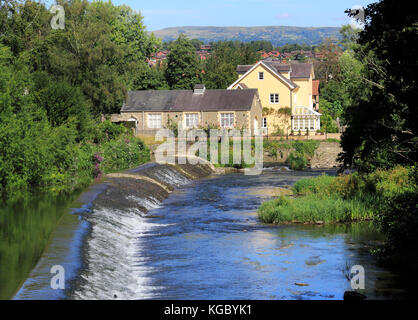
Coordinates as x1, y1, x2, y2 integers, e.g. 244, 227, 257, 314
228, 61, 321, 134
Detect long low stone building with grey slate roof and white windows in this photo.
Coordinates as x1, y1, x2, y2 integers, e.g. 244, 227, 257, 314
111, 85, 262, 134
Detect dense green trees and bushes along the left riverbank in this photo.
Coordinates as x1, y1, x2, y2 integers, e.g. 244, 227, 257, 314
0, 0, 155, 200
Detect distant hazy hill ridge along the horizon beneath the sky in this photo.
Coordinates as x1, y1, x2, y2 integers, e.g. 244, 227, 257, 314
153, 26, 340, 46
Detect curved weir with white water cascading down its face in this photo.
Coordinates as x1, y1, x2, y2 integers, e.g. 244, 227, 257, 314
67, 164, 213, 299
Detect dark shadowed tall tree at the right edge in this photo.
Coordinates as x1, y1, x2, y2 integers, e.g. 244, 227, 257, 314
341, 0, 418, 171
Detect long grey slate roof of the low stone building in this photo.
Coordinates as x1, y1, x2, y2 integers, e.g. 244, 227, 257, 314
121, 89, 258, 112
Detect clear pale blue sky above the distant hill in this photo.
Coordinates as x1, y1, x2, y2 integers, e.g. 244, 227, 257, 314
113, 0, 376, 31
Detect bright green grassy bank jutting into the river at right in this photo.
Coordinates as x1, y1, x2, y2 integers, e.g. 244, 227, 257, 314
258, 167, 417, 228
